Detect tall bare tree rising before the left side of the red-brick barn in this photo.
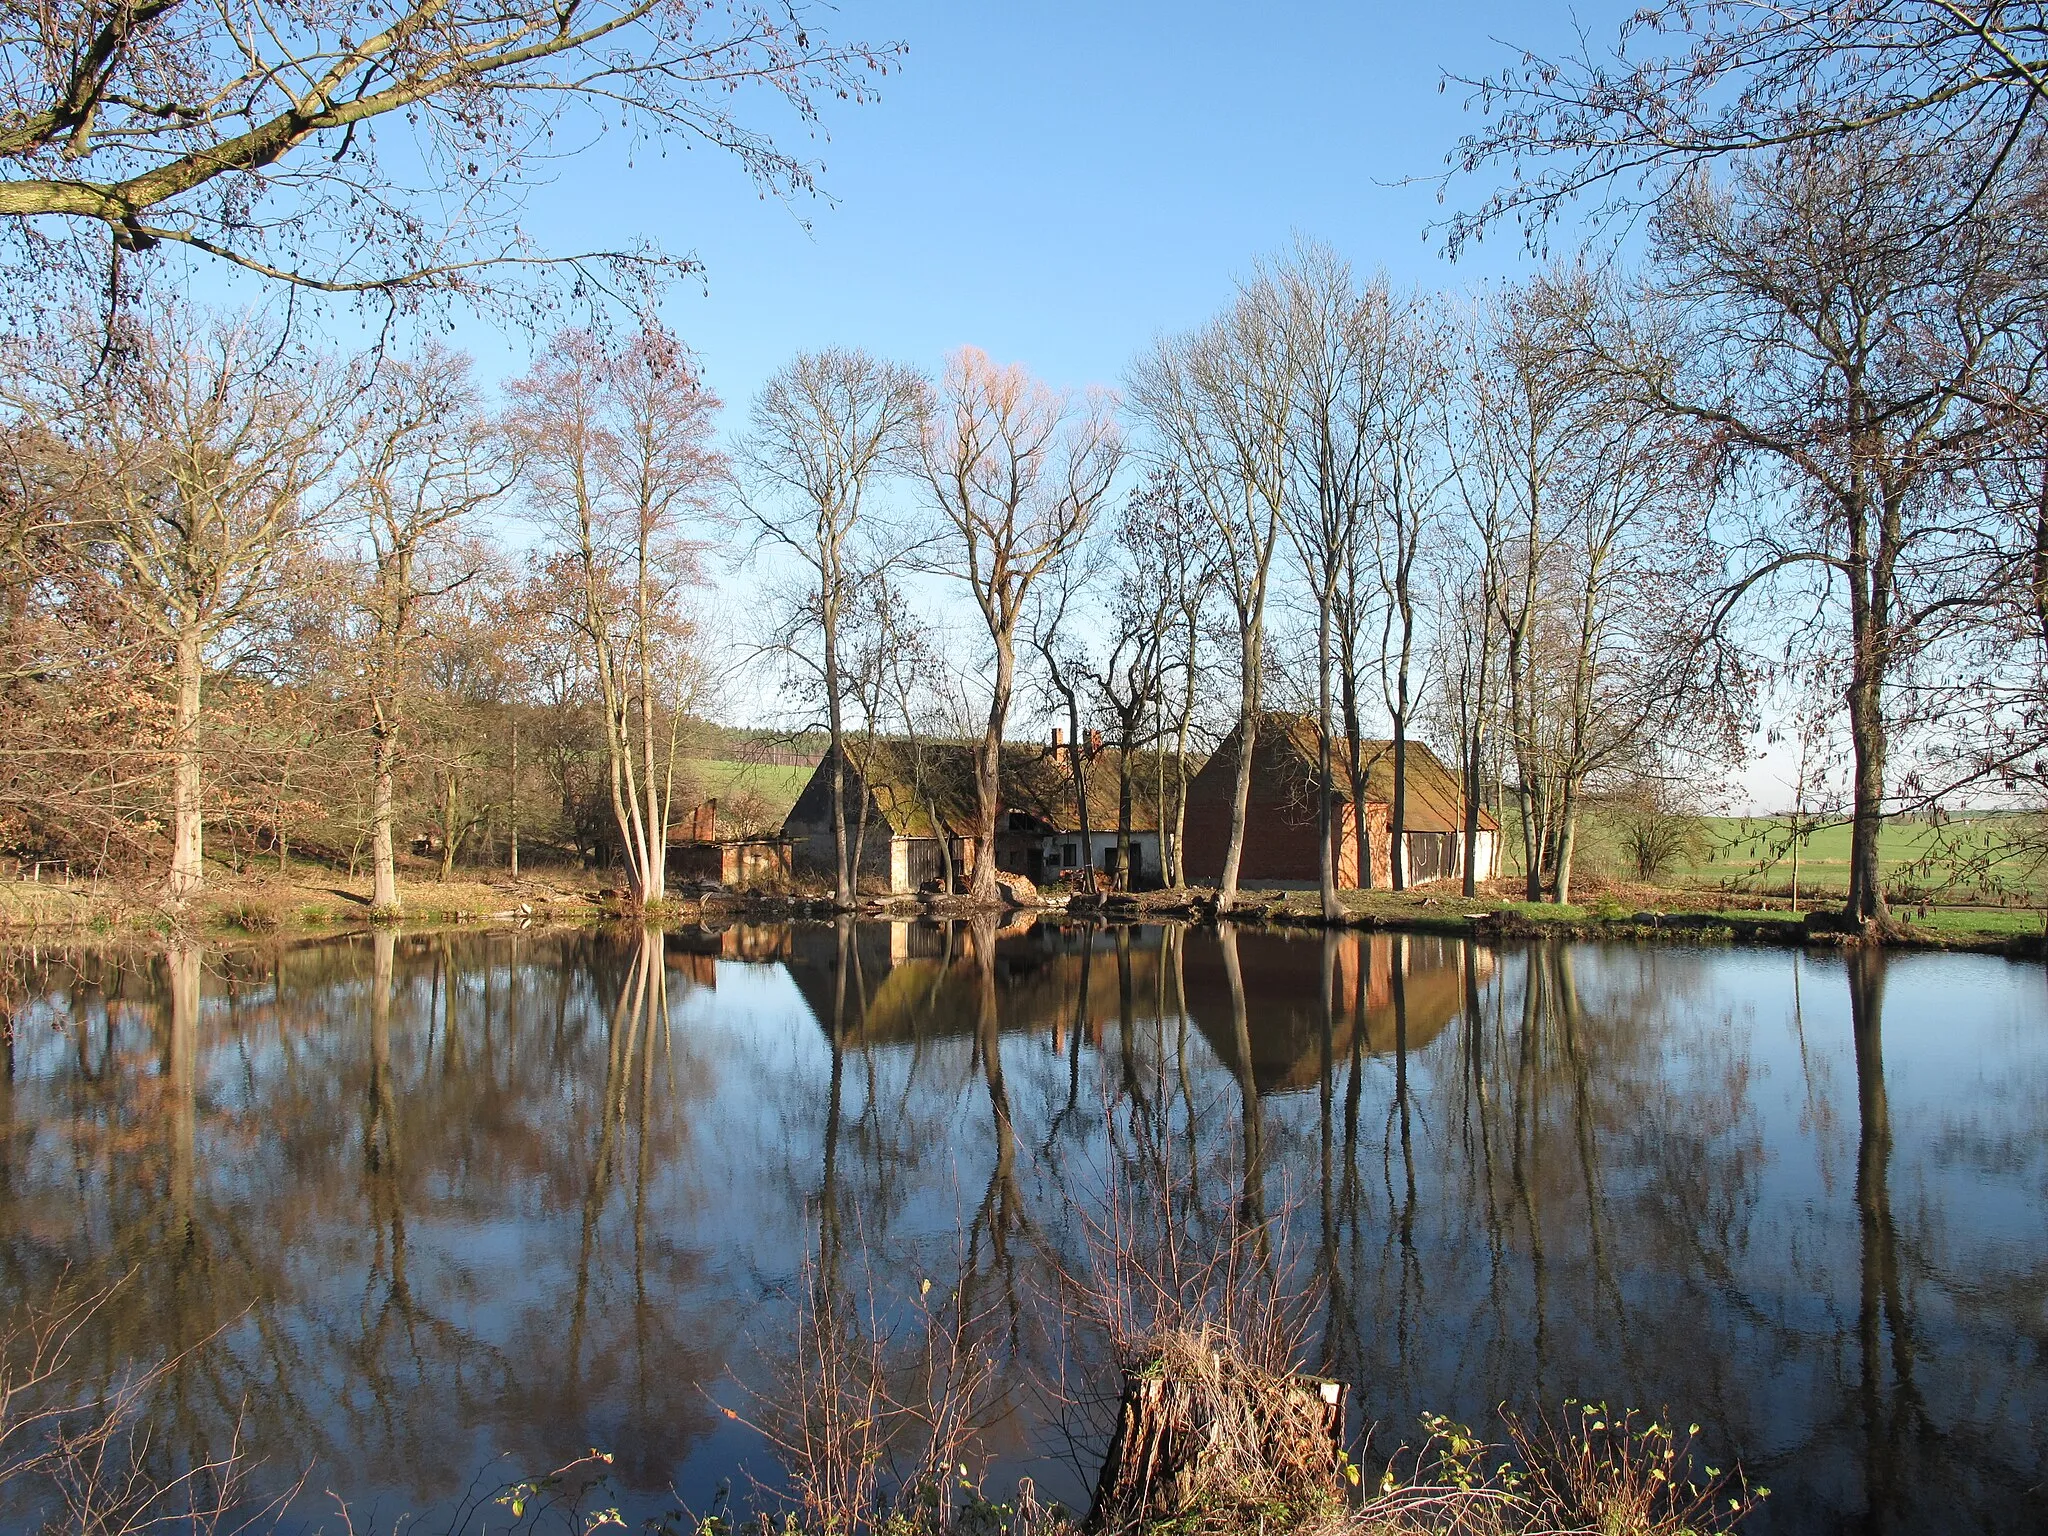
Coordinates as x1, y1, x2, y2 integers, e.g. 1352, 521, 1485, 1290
1130, 268, 1294, 911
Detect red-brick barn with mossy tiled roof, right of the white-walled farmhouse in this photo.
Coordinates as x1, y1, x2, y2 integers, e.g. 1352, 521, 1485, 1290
1186, 711, 1499, 889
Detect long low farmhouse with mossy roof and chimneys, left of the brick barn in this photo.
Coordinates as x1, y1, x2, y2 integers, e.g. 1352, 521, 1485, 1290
782, 731, 1159, 893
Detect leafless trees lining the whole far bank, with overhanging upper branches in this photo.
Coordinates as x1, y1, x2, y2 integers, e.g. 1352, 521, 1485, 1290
0, 4, 2048, 924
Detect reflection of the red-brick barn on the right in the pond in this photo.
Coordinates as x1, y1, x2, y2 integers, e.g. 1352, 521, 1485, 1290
1184, 932, 1493, 1094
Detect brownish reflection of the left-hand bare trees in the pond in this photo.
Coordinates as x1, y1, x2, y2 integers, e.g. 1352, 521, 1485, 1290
0, 930, 735, 1501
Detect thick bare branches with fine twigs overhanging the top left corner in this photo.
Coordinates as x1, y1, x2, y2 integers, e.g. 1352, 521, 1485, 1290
0, 0, 901, 301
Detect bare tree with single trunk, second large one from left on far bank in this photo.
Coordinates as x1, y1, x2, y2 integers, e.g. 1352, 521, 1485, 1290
352, 346, 514, 913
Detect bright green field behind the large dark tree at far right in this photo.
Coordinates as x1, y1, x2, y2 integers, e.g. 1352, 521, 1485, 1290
1669, 815, 2048, 905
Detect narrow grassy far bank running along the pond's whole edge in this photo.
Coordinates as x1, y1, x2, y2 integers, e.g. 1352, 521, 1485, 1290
0, 870, 2048, 961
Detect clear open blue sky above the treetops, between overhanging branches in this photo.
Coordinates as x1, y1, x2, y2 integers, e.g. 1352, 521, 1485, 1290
432, 0, 1581, 406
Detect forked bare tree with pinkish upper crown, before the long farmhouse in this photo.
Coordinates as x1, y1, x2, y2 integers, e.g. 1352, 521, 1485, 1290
924, 348, 1122, 903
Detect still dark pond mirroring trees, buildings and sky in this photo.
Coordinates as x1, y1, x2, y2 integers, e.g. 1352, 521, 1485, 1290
0, 922, 2048, 1532
